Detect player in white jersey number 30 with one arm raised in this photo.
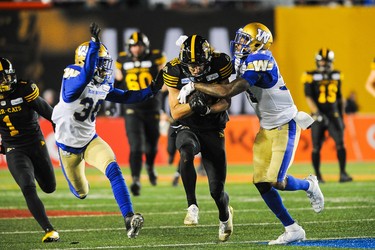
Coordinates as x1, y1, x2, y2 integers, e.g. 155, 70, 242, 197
52, 23, 160, 238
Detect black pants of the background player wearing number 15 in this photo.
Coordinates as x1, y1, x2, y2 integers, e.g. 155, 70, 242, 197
311, 117, 346, 178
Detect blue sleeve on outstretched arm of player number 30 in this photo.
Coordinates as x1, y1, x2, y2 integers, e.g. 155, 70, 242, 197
106, 86, 153, 104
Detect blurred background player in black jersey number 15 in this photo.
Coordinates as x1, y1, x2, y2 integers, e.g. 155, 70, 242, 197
302, 48, 353, 182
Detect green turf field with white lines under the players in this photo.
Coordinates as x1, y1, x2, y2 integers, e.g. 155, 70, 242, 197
0, 163, 375, 250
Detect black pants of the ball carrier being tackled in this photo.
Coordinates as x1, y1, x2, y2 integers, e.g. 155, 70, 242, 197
176, 129, 229, 221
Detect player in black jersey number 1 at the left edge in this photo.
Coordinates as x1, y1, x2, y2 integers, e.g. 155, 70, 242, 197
0, 58, 60, 242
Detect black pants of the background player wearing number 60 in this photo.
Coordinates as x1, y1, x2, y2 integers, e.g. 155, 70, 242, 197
125, 111, 160, 179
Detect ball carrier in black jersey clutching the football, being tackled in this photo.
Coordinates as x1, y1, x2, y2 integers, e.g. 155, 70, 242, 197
162, 35, 233, 241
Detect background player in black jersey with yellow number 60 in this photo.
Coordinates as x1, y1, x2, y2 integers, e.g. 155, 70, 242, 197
115, 32, 167, 196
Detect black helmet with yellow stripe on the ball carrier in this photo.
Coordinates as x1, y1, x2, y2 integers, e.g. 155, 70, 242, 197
179, 35, 212, 78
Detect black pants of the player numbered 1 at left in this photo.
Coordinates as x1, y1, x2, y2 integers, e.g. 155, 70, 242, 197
6, 143, 56, 230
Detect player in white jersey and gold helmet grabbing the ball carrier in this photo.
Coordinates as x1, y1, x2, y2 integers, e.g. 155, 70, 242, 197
179, 23, 324, 245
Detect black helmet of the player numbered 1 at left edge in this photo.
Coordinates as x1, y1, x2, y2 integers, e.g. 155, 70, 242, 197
0, 57, 17, 97
